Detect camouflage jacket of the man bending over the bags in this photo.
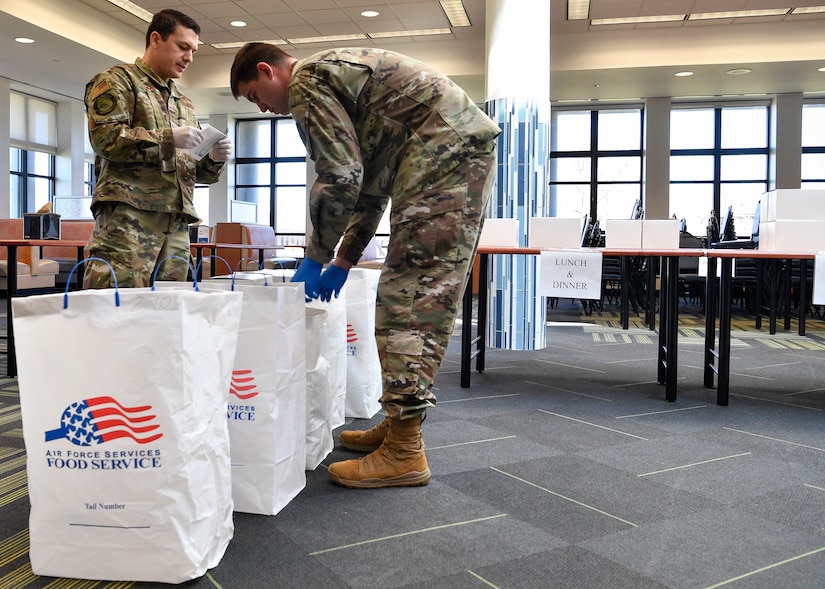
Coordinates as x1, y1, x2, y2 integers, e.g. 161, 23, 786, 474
288, 49, 500, 263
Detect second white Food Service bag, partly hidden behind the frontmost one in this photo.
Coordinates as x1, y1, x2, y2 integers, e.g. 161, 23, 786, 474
199, 280, 307, 515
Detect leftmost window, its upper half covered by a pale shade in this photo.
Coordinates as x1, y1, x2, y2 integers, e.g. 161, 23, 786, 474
9, 92, 57, 217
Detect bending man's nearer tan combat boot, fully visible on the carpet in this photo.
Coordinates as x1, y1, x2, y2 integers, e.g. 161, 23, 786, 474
329, 415, 430, 489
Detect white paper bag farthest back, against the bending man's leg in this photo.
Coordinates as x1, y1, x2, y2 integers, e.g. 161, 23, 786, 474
342, 268, 382, 419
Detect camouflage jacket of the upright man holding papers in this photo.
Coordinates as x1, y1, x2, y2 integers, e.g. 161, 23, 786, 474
86, 58, 224, 221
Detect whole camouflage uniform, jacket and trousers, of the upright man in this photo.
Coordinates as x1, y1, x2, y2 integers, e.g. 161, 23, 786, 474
84, 58, 224, 288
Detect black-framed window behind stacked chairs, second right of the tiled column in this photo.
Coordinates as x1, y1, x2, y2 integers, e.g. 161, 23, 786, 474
670, 104, 769, 237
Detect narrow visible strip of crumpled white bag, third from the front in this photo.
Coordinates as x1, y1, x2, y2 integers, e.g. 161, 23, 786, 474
304, 308, 334, 470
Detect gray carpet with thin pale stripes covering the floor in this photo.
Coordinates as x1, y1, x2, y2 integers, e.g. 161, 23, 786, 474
0, 301, 825, 589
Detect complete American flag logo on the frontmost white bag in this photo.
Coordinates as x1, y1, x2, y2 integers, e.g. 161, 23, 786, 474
46, 396, 163, 446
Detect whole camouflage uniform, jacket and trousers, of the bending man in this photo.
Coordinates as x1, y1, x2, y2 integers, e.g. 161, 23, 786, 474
288, 49, 501, 418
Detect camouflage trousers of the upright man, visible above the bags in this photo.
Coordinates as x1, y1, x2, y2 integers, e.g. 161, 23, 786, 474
83, 203, 190, 288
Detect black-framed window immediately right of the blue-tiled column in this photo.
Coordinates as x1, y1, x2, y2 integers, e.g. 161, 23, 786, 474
550, 108, 642, 221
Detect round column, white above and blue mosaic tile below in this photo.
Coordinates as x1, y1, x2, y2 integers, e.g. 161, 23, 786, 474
481, 0, 550, 350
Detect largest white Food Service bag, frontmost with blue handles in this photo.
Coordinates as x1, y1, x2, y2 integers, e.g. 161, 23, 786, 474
13, 288, 242, 583
